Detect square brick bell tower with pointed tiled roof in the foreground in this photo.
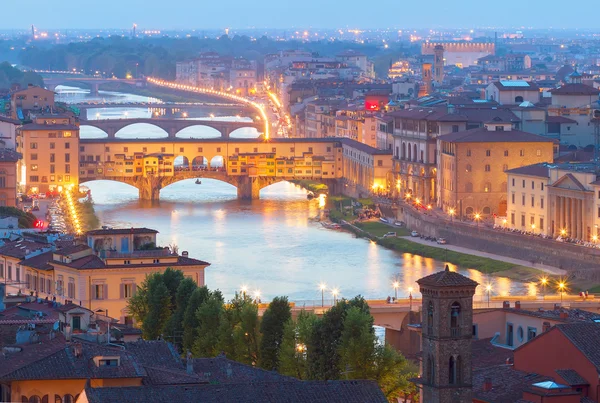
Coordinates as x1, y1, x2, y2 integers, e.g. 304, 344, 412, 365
417, 266, 478, 403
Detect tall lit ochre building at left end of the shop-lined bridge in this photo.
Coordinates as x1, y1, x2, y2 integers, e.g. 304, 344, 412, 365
17, 115, 79, 194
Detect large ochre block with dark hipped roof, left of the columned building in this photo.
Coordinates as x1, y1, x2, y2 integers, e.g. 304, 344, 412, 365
437, 122, 554, 218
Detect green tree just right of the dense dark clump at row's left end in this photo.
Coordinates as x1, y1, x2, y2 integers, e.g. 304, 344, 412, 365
192, 293, 224, 357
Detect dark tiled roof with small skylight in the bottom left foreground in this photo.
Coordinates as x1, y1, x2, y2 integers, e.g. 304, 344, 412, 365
0, 341, 146, 380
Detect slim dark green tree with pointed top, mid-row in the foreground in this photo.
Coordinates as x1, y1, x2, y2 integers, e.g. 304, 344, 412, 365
260, 297, 292, 370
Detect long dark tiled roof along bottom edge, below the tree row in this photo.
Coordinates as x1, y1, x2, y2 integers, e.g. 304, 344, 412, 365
85, 381, 387, 403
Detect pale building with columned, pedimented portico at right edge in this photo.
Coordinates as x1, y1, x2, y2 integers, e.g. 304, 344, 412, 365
506, 163, 600, 242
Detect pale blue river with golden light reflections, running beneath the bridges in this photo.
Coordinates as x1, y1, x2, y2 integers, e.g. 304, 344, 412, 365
58, 87, 527, 303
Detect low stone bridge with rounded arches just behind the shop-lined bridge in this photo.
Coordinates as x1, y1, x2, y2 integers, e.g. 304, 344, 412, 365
80, 118, 265, 139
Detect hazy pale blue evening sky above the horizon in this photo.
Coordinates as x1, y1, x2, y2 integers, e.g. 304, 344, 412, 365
0, 0, 598, 30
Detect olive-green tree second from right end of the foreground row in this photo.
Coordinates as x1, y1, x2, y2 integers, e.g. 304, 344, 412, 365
338, 306, 377, 379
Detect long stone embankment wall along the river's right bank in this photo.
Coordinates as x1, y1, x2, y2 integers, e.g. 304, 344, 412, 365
397, 204, 600, 279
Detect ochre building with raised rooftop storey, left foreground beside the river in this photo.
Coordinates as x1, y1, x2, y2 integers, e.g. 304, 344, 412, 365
0, 228, 209, 323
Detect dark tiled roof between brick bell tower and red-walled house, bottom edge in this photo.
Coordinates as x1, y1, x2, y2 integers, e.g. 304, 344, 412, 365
473, 365, 552, 403
